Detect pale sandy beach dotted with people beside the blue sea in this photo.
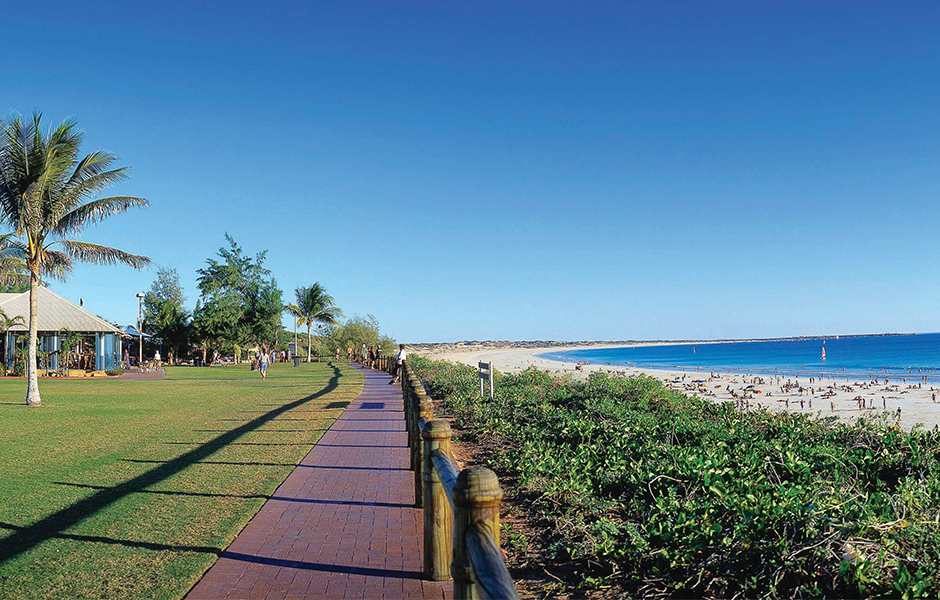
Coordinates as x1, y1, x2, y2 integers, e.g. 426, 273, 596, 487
417, 344, 940, 429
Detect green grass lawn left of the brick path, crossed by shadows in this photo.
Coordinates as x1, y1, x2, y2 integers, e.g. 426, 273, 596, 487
0, 364, 362, 598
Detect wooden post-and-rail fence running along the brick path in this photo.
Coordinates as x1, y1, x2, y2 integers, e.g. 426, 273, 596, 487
375, 357, 519, 600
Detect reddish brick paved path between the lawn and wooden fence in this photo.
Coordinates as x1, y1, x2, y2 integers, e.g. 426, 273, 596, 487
187, 369, 452, 600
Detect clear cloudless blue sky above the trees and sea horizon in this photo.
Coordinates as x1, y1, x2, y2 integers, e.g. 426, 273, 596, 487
0, 1, 940, 342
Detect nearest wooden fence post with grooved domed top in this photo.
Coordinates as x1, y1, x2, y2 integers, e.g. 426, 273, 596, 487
452, 467, 503, 600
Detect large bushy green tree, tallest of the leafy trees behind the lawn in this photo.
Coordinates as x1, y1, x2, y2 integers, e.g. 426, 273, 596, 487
193, 233, 283, 350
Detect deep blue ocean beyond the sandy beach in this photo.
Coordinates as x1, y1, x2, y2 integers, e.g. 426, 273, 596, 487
539, 333, 940, 381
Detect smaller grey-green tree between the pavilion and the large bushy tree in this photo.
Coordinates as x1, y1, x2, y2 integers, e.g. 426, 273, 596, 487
144, 267, 192, 364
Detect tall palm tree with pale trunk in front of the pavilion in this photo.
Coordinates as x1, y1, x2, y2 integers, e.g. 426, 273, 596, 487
0, 113, 150, 406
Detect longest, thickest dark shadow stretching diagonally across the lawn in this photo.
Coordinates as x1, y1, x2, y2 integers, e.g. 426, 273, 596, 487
0, 367, 340, 563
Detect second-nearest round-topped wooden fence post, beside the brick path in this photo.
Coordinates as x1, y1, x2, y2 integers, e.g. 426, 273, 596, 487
421, 421, 454, 581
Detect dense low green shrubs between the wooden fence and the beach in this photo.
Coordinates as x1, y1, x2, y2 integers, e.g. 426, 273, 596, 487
409, 357, 940, 598
